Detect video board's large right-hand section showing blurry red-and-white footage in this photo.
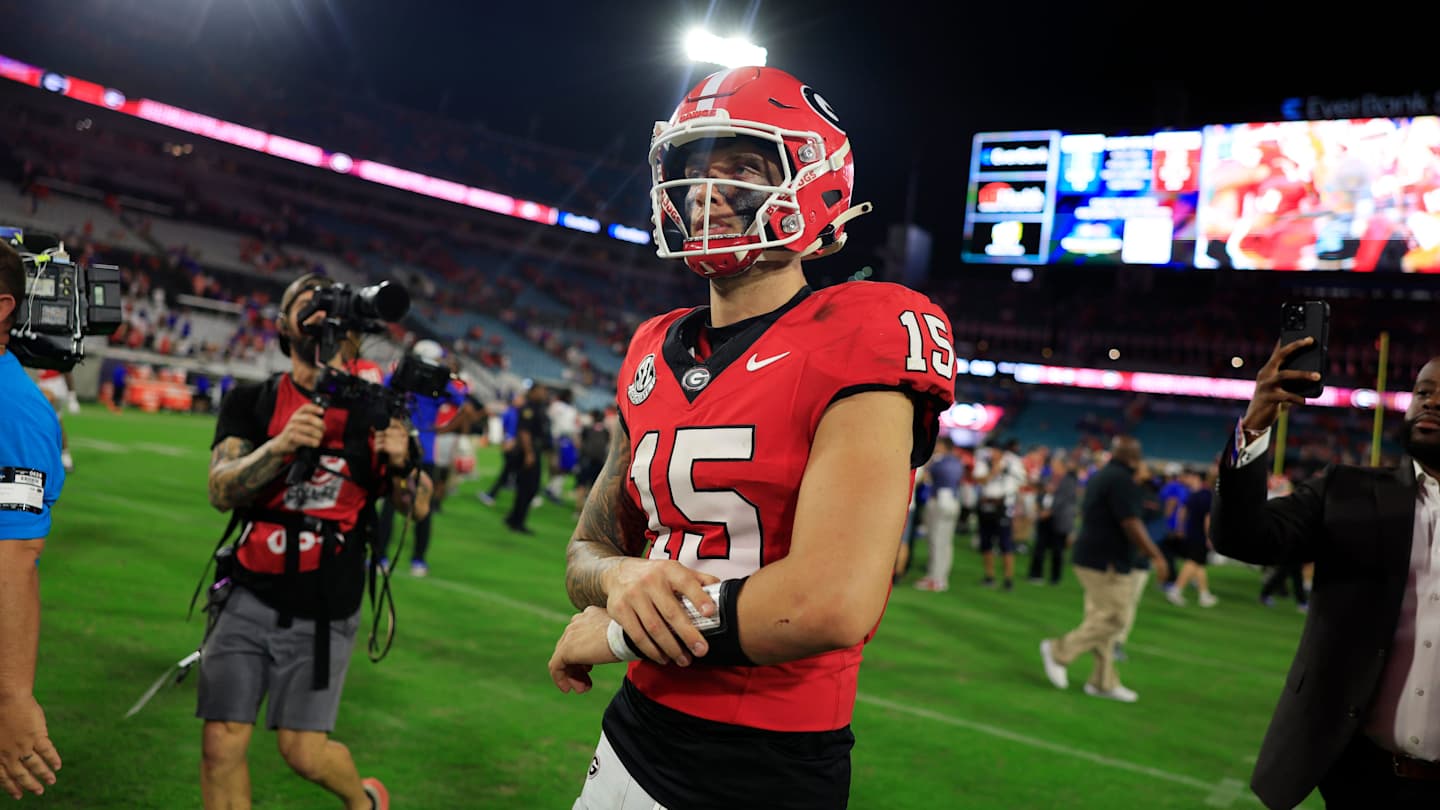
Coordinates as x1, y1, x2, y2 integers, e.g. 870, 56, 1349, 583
1195, 115, 1440, 272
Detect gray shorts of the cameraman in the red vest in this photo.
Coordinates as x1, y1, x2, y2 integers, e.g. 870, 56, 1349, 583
194, 579, 360, 734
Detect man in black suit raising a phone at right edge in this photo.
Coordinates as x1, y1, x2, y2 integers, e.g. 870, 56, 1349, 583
1211, 339, 1440, 810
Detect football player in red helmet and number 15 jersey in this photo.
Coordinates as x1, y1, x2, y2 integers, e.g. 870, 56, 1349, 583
550, 66, 955, 810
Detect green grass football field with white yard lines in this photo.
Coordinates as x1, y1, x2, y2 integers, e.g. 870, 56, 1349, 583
30, 408, 1320, 810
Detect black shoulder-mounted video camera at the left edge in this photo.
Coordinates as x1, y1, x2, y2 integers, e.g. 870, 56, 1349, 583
0, 225, 124, 372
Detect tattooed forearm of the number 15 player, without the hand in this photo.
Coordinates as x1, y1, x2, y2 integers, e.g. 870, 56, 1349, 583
564, 430, 648, 607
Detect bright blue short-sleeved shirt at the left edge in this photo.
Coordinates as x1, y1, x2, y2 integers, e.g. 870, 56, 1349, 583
0, 352, 65, 540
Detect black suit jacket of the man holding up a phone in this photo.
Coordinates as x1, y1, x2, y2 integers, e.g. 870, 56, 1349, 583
1210, 440, 1416, 810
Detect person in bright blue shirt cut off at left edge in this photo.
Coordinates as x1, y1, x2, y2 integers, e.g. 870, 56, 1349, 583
0, 242, 65, 798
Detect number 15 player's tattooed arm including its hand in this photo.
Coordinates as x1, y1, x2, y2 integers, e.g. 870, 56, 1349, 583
564, 425, 719, 663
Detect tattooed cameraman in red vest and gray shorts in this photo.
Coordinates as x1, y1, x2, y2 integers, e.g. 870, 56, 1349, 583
196, 275, 429, 810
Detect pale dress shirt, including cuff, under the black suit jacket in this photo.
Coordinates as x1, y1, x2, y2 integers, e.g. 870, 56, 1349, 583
1234, 431, 1440, 761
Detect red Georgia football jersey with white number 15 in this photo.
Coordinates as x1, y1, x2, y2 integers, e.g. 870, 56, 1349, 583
618, 281, 955, 731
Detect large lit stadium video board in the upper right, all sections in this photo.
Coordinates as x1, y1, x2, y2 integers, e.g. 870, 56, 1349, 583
962, 117, 1440, 272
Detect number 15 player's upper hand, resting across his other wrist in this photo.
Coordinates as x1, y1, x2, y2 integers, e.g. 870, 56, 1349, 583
605, 559, 720, 666
